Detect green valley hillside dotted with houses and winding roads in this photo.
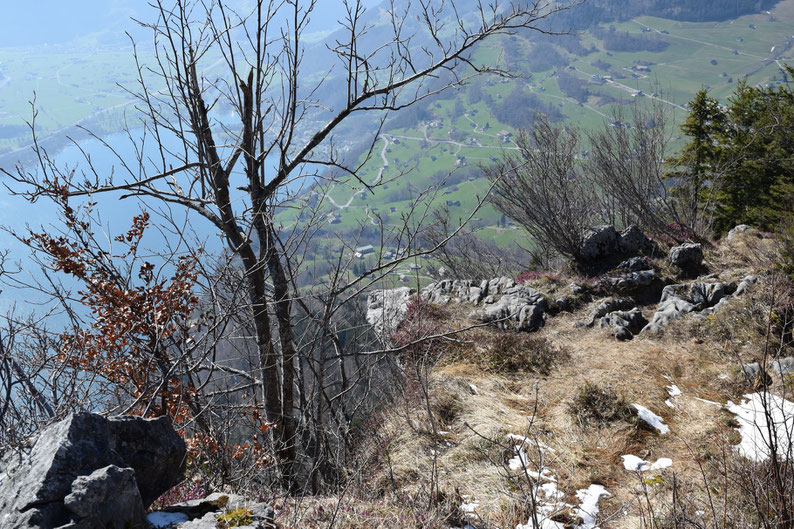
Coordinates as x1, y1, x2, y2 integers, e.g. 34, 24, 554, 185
284, 0, 794, 280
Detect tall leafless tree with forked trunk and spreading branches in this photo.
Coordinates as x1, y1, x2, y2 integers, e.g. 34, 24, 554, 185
3, 0, 567, 487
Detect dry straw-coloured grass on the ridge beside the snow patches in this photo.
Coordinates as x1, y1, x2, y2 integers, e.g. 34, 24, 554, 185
352, 235, 784, 528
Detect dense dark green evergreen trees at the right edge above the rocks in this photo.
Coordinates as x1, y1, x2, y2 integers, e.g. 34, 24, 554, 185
671, 66, 794, 233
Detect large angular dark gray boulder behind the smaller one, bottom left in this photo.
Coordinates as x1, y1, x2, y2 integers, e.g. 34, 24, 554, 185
0, 413, 185, 528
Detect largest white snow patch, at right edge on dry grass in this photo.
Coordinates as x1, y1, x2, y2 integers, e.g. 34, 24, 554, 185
725, 393, 794, 461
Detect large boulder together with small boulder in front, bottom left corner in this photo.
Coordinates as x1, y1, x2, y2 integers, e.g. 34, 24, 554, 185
0, 413, 185, 529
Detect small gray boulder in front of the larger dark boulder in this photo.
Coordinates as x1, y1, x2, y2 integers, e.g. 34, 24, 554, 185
63, 465, 147, 529
